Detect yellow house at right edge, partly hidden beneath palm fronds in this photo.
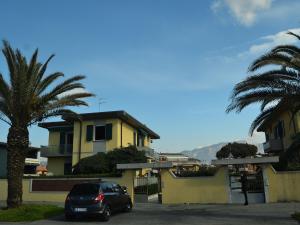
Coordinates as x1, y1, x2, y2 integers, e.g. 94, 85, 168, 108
257, 108, 300, 153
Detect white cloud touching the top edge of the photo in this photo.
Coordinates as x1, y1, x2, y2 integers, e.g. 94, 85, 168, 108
211, 0, 272, 26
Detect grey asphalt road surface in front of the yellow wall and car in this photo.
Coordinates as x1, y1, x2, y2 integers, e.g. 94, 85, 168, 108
0, 203, 300, 225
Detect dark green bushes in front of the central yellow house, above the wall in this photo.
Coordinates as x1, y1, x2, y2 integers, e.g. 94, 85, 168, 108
73, 146, 147, 174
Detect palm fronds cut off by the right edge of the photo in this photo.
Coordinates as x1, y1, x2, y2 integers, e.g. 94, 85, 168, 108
226, 32, 300, 134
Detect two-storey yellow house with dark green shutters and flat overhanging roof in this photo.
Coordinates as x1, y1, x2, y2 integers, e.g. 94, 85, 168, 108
39, 111, 160, 175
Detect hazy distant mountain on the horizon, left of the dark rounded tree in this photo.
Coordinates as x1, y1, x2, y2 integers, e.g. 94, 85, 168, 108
181, 141, 263, 164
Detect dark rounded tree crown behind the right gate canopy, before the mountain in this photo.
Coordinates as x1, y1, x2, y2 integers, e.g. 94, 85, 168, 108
216, 142, 257, 159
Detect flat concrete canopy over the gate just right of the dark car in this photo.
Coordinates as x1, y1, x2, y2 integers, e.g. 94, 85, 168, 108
117, 162, 173, 170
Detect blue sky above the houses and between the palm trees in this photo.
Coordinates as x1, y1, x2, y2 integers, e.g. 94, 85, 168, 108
0, 0, 300, 152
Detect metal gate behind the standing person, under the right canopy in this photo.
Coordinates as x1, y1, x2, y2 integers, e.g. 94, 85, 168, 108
229, 172, 265, 204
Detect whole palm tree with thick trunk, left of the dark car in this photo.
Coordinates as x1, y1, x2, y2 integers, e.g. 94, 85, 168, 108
0, 41, 92, 208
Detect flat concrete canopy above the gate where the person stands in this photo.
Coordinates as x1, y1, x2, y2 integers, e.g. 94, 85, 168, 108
211, 156, 279, 165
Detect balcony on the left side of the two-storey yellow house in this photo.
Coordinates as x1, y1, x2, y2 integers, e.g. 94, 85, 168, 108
41, 144, 73, 157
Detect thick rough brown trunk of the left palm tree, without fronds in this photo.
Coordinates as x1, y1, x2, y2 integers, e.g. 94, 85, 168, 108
7, 125, 29, 208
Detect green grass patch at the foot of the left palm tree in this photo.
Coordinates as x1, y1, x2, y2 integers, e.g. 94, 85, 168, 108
0, 205, 64, 222
